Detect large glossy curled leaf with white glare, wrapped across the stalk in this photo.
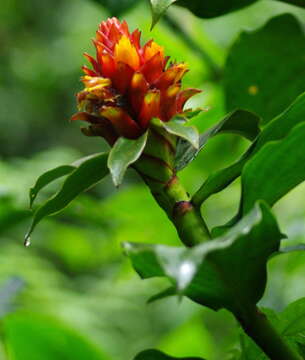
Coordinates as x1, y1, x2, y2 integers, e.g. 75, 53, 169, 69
124, 203, 282, 313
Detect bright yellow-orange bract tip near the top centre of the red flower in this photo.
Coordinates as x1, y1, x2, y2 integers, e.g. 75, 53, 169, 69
114, 35, 140, 70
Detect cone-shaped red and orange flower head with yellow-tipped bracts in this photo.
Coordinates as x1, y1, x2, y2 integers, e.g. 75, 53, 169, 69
72, 18, 200, 144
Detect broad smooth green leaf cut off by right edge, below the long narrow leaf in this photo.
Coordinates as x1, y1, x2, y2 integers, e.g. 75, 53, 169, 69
241, 124, 305, 214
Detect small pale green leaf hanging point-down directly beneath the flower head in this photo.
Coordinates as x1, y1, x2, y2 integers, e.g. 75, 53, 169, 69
107, 132, 147, 186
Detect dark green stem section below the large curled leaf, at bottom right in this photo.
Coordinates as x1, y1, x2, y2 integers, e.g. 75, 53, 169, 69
236, 306, 302, 360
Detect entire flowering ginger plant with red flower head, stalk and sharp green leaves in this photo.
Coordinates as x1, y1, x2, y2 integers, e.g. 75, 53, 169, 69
25, 18, 305, 360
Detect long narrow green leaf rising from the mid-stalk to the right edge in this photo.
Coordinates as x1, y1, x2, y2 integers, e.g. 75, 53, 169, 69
193, 93, 305, 206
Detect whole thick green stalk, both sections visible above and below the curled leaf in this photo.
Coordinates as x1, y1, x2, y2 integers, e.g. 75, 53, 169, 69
134, 126, 302, 360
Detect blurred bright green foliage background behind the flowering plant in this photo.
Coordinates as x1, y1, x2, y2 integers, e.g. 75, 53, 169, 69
0, 0, 305, 360
